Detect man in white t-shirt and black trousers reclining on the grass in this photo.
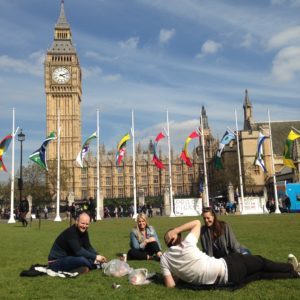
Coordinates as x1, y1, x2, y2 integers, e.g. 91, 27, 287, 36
160, 220, 300, 288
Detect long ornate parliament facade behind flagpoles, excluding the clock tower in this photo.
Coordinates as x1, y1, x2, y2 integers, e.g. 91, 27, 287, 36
81, 107, 218, 202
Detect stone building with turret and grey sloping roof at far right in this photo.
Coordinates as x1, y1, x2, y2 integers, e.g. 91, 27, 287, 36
213, 90, 300, 195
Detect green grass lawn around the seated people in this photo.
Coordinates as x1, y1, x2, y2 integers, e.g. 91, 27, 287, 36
0, 214, 300, 300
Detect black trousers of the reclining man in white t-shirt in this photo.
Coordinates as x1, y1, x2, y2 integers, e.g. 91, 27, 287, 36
224, 253, 300, 284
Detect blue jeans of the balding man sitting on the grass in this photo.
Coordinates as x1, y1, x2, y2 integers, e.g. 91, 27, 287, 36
49, 256, 95, 272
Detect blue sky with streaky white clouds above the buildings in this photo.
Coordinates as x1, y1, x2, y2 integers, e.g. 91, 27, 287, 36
0, 0, 300, 181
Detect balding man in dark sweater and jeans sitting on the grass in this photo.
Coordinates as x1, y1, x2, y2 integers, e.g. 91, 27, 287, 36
48, 213, 107, 274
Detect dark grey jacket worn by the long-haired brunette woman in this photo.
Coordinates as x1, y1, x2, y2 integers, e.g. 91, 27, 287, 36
200, 223, 241, 258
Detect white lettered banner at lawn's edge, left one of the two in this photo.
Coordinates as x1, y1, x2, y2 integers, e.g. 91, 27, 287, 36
174, 198, 202, 216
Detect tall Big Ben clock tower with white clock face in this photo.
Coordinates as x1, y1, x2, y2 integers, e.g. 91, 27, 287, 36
45, 0, 82, 198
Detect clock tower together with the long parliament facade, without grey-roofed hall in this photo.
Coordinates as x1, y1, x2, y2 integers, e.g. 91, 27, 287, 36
45, 0, 217, 199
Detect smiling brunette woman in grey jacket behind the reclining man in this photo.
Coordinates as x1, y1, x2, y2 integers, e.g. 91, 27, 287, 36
200, 207, 251, 258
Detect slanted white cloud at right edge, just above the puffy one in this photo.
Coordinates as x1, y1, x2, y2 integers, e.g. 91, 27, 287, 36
268, 26, 300, 49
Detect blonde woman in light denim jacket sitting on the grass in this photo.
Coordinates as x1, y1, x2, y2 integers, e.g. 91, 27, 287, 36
127, 213, 162, 260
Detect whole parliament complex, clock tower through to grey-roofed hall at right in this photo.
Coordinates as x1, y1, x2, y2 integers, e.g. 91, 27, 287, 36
44, 0, 300, 200
